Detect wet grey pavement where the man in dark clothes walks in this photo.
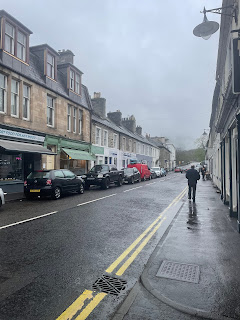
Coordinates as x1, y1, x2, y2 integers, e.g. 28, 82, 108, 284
113, 180, 240, 320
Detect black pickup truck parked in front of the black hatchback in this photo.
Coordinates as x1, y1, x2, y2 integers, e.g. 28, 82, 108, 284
83, 164, 124, 190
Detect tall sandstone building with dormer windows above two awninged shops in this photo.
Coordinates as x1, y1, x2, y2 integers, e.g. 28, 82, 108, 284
0, 10, 95, 196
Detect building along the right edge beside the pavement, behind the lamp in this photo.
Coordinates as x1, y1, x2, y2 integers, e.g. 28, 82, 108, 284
206, 0, 240, 232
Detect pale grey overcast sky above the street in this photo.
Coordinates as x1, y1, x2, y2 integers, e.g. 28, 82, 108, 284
2, 0, 221, 149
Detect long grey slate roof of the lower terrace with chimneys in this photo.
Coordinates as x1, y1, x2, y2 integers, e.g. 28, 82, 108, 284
92, 114, 158, 148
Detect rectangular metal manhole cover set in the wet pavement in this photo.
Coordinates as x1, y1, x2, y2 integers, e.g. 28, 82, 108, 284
157, 260, 200, 283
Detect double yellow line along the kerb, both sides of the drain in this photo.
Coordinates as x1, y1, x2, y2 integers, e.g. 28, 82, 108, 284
56, 187, 187, 320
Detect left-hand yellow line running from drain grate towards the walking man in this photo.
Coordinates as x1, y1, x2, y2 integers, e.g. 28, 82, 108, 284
105, 190, 184, 273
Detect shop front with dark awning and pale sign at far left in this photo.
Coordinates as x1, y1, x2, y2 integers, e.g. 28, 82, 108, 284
0, 127, 54, 198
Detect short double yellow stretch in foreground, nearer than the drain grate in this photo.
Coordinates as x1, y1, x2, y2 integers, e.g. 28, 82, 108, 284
56, 290, 107, 320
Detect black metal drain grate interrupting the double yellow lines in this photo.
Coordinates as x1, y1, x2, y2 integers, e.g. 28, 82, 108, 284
93, 275, 127, 296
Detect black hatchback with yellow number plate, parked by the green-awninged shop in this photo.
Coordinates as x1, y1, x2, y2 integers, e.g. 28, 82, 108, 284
24, 169, 84, 199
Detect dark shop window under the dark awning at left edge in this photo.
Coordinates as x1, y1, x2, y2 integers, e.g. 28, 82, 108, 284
0, 154, 23, 181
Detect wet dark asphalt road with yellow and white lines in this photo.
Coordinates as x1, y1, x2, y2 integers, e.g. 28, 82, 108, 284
0, 173, 186, 320
